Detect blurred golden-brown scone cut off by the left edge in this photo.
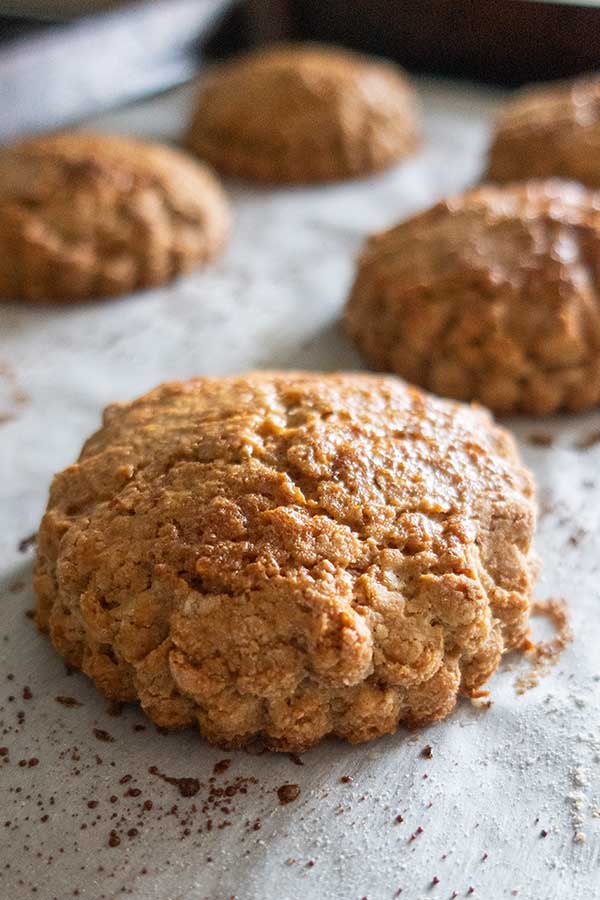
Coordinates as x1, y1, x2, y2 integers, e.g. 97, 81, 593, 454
0, 132, 229, 303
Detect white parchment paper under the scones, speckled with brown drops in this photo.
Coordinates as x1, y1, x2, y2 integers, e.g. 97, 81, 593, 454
0, 81, 600, 900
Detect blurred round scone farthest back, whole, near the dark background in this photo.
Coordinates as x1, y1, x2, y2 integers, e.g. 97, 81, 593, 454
186, 44, 420, 183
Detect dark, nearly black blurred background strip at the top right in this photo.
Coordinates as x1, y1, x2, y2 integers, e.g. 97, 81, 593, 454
227, 0, 600, 85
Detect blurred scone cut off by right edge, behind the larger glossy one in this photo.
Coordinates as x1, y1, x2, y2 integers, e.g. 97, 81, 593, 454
487, 78, 600, 188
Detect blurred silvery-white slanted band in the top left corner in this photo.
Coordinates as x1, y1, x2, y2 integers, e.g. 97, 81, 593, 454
0, 0, 234, 141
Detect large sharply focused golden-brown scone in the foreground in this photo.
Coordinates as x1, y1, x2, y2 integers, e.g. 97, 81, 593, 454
35, 372, 534, 750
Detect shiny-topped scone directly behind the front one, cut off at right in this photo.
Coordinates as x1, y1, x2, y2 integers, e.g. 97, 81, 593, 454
345, 181, 600, 415
